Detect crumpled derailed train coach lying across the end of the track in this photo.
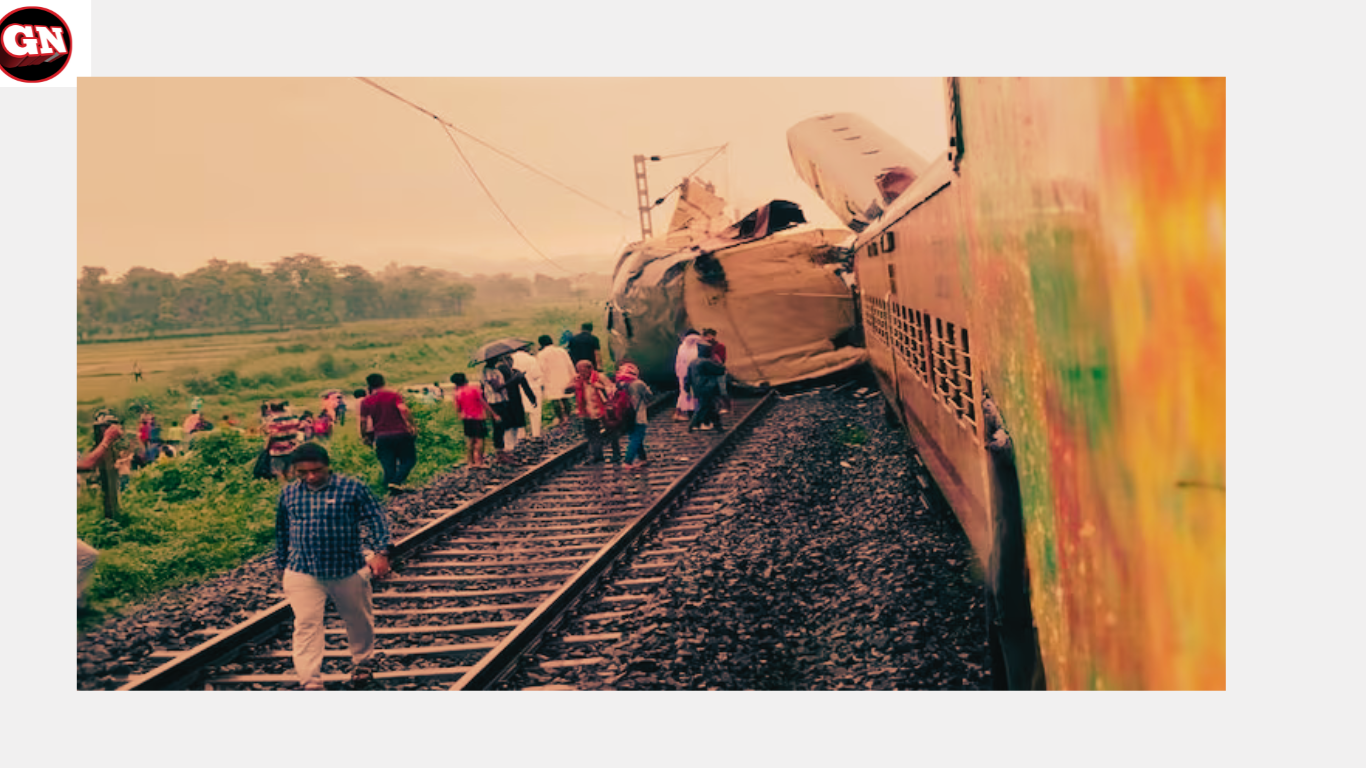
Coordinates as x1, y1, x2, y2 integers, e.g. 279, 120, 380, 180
607, 179, 867, 388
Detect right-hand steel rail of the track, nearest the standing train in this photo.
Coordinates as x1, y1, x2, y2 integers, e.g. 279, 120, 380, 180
449, 391, 773, 690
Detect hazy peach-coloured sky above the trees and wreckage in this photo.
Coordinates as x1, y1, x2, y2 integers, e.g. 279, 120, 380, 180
76, 78, 945, 276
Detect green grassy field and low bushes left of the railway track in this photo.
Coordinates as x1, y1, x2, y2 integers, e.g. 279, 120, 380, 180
76, 297, 601, 631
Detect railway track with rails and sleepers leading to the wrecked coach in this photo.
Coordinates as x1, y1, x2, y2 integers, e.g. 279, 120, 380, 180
120, 398, 770, 690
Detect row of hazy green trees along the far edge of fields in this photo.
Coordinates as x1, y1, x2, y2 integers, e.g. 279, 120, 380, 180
76, 253, 587, 342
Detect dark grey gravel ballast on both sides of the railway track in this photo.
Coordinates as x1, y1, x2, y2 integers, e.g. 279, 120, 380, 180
76, 385, 990, 690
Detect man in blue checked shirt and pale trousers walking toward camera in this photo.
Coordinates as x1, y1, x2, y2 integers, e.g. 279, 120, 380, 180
275, 443, 389, 690
